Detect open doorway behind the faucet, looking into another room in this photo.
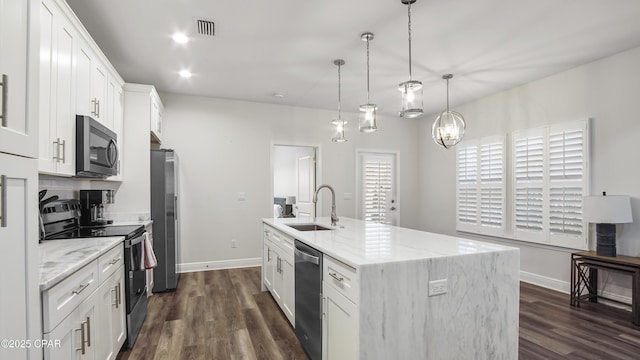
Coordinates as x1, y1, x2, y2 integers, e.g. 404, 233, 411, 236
272, 145, 318, 220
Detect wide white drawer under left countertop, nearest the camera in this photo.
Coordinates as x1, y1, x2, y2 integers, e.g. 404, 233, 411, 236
42, 261, 98, 333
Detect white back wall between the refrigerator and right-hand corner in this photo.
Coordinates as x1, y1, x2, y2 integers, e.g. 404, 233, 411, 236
160, 93, 418, 269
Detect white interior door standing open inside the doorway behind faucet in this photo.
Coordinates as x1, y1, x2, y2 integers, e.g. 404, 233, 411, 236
295, 148, 316, 218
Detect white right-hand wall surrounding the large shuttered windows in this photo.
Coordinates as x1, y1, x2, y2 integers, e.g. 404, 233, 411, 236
419, 48, 640, 296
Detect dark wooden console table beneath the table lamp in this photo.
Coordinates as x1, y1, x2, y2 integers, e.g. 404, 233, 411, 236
571, 251, 640, 326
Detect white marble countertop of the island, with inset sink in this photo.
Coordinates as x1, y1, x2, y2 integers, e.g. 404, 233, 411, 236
262, 217, 518, 267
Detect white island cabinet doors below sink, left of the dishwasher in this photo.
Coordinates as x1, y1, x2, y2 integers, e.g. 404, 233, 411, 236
262, 225, 296, 326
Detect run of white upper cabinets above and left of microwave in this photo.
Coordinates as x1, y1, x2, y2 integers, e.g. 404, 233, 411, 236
35, 0, 124, 176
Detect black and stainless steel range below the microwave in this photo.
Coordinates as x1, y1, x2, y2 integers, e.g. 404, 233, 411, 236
41, 199, 147, 348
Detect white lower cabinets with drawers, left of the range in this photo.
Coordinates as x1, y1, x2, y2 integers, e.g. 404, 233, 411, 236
42, 244, 127, 360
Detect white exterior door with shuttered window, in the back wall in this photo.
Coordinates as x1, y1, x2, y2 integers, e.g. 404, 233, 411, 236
359, 152, 400, 225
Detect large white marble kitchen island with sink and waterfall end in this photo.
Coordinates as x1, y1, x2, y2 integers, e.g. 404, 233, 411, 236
263, 218, 520, 359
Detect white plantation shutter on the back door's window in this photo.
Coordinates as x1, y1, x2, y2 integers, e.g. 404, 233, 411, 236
363, 156, 394, 224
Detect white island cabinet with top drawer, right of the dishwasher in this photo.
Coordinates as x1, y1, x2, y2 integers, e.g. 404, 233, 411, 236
322, 255, 359, 360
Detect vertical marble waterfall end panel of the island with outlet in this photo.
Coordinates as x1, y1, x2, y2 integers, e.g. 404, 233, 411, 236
358, 249, 520, 360
